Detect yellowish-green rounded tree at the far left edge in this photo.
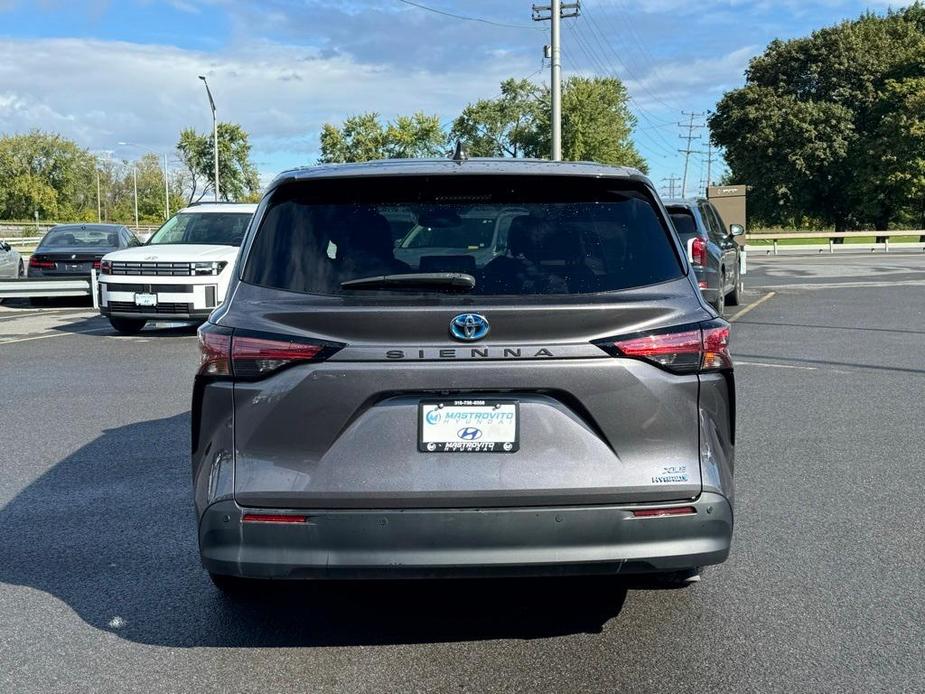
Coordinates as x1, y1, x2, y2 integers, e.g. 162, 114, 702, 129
0, 130, 96, 219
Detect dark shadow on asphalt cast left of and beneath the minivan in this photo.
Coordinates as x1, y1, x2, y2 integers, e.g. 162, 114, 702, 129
0, 412, 626, 647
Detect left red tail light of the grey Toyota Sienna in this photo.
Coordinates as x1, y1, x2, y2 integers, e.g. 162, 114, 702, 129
199, 323, 342, 379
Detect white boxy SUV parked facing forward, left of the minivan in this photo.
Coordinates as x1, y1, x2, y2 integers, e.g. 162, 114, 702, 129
99, 203, 257, 335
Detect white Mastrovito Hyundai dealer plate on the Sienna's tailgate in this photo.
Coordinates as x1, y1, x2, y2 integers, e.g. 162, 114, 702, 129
418, 400, 520, 453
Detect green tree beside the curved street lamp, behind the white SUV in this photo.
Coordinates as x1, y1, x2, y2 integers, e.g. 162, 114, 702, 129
177, 123, 260, 202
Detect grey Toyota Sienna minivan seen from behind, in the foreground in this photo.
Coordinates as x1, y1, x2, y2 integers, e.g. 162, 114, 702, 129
192, 160, 735, 589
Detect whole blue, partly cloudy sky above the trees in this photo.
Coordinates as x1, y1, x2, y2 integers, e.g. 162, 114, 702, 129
0, 0, 902, 192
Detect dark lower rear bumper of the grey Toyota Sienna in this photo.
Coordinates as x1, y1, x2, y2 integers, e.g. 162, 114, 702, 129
199, 493, 733, 579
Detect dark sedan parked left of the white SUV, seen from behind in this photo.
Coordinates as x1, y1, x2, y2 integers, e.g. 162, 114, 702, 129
29, 224, 141, 277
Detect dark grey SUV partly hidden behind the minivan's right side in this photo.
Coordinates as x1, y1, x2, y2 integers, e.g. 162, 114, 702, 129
665, 198, 745, 315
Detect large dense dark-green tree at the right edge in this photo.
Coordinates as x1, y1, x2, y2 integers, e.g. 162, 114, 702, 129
709, 4, 925, 229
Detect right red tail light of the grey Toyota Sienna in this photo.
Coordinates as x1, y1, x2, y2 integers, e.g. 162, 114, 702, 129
595, 320, 732, 373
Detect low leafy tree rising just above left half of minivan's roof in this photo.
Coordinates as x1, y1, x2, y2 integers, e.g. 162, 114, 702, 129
319, 112, 446, 164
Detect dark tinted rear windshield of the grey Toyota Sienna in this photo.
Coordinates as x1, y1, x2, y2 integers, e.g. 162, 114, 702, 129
243, 176, 682, 295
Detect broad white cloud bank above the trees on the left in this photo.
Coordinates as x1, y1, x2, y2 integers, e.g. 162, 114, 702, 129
0, 34, 533, 177
